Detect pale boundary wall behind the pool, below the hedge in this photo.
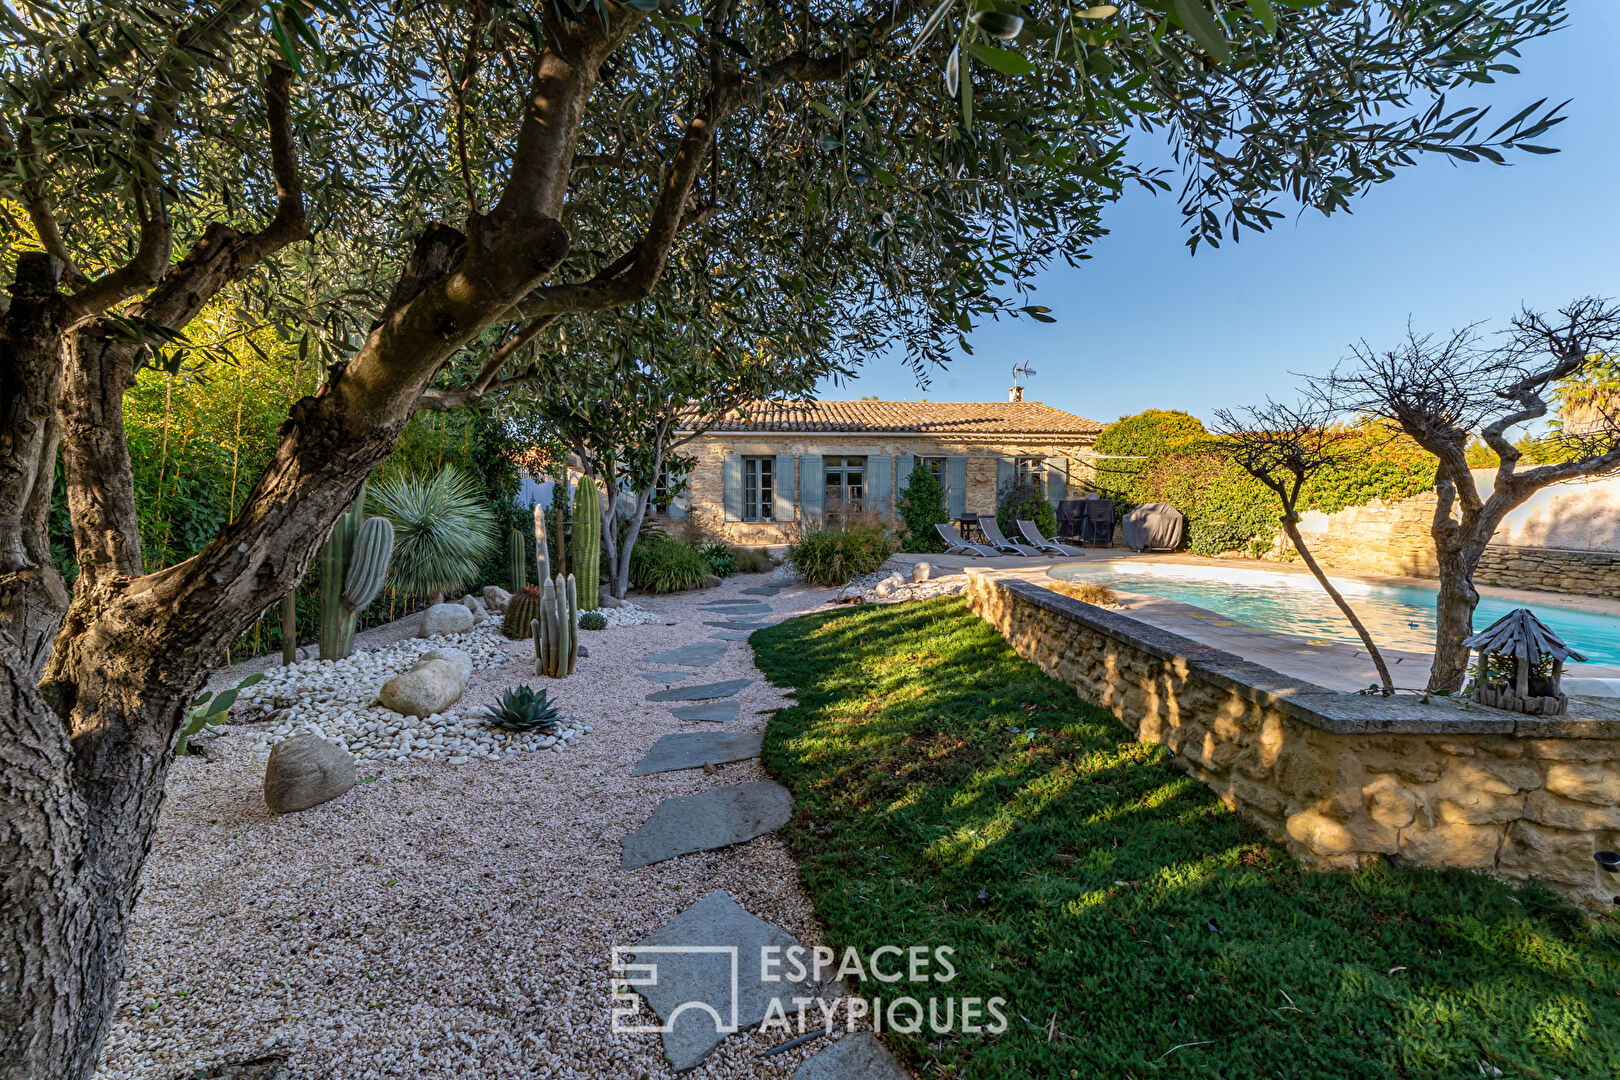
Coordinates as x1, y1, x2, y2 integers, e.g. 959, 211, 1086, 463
1278, 470, 1620, 596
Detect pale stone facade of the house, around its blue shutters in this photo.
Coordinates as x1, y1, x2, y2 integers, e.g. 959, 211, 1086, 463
676, 432, 1095, 544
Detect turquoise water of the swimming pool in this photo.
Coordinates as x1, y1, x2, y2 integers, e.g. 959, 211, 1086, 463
1051, 562, 1620, 665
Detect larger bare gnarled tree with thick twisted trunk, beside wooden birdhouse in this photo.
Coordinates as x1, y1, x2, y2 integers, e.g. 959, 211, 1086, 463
1315, 298, 1620, 691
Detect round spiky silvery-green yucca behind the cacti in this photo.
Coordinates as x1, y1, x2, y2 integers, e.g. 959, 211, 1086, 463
371, 465, 496, 604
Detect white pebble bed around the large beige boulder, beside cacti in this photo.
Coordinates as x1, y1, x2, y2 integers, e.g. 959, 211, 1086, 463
232, 620, 590, 764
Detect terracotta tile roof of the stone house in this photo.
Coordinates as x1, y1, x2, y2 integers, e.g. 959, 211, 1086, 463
696, 402, 1103, 436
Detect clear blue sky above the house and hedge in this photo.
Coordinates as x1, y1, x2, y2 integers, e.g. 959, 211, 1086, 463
823, 8, 1620, 421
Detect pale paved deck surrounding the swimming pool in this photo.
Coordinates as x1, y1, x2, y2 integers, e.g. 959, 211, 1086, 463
896, 547, 1620, 690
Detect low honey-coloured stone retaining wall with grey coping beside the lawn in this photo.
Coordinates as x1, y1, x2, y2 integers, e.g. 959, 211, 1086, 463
967, 570, 1620, 910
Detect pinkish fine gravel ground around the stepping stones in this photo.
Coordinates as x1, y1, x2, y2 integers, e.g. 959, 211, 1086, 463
99, 575, 868, 1080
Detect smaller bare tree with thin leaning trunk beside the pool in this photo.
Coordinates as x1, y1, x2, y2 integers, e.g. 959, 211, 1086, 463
1215, 400, 1395, 693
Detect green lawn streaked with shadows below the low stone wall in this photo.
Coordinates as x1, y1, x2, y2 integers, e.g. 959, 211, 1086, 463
752, 597, 1620, 1080
